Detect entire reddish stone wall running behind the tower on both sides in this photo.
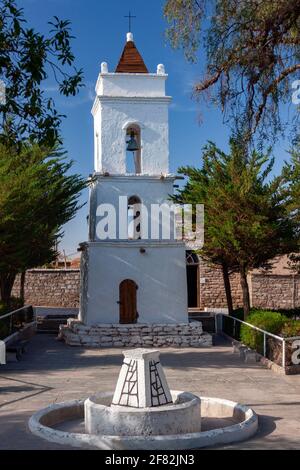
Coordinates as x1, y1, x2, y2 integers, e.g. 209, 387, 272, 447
13, 262, 300, 310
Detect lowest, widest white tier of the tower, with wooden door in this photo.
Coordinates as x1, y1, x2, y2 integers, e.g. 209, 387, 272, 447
79, 240, 188, 326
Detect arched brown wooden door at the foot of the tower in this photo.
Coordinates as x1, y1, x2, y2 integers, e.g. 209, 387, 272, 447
119, 279, 138, 323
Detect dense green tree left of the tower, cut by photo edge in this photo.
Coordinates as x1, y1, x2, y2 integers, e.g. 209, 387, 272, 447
0, 143, 86, 305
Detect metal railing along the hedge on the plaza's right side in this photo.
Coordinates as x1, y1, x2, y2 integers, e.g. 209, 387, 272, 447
215, 313, 300, 369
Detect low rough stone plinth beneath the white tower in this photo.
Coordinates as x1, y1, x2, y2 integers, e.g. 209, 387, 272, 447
58, 318, 212, 348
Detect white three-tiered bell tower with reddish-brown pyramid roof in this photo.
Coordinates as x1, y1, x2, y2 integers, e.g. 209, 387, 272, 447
80, 33, 188, 324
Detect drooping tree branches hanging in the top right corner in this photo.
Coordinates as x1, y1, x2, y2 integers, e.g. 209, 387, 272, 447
164, 0, 300, 139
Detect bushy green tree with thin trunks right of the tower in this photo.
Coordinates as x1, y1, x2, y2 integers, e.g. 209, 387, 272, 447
175, 139, 297, 318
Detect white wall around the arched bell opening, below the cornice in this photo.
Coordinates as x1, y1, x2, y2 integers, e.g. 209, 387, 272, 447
95, 99, 169, 175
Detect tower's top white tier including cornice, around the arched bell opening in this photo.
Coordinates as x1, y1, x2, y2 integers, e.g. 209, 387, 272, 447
92, 74, 171, 175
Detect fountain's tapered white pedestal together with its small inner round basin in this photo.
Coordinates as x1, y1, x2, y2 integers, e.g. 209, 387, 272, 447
85, 349, 201, 436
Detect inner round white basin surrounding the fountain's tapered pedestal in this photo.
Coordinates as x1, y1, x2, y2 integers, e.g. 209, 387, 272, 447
84, 391, 201, 437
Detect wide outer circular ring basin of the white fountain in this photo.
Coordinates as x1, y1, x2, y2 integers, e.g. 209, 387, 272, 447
29, 391, 258, 450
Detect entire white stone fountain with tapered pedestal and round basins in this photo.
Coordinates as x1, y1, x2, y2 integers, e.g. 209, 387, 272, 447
29, 349, 258, 450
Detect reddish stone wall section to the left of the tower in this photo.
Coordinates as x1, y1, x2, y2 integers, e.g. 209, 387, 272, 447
13, 269, 80, 307
